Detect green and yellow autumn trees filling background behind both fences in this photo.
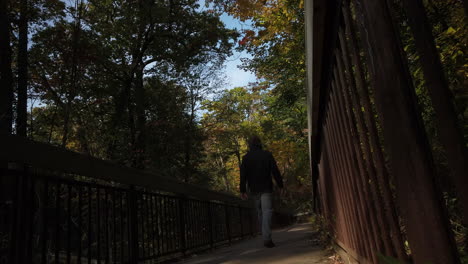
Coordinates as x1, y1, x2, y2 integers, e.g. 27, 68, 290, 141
0, 0, 468, 217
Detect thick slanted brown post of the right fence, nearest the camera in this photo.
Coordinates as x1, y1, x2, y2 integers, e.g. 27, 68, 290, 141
357, 0, 459, 263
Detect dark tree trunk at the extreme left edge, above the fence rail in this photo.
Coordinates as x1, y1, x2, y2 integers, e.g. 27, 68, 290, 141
0, 0, 13, 134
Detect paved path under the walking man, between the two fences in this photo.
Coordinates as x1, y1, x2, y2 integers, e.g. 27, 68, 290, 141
179, 224, 331, 264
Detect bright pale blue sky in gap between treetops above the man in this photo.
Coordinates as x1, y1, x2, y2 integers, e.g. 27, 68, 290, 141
221, 14, 257, 89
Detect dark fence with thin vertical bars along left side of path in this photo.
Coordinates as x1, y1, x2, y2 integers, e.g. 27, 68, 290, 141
0, 136, 291, 263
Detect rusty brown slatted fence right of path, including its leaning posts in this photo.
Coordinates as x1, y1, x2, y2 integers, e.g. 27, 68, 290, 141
305, 0, 468, 264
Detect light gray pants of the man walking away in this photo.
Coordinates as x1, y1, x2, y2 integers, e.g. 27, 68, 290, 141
253, 193, 273, 241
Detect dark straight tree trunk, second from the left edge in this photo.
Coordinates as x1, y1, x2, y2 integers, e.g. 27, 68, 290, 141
16, 0, 28, 137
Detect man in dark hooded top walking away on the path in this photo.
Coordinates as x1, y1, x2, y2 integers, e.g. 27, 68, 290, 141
240, 136, 284, 248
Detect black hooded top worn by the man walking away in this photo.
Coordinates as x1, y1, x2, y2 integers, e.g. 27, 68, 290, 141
240, 146, 283, 193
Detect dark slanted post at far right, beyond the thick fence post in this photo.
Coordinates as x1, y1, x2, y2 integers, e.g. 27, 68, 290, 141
402, 0, 468, 224
